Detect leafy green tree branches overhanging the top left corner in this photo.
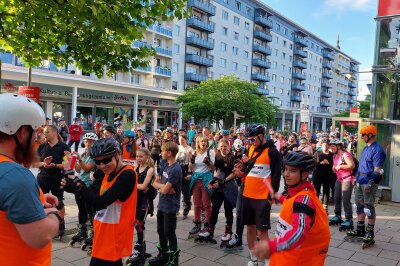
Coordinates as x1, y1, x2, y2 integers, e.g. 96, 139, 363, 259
0, 0, 188, 77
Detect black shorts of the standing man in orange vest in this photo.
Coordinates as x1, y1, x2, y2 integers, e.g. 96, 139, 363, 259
241, 196, 271, 231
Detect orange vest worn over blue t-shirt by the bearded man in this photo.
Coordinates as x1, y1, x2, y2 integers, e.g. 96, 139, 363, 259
0, 155, 51, 266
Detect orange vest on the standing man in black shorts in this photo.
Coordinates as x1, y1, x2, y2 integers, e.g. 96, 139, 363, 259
243, 146, 271, 199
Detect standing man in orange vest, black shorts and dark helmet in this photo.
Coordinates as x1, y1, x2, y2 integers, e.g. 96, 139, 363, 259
235, 124, 282, 265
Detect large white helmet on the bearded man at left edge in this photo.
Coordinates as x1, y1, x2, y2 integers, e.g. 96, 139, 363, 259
0, 93, 46, 135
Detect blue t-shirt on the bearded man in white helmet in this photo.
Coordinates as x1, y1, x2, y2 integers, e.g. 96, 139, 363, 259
0, 162, 46, 224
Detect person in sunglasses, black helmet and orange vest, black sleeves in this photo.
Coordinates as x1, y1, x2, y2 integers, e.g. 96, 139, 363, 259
61, 138, 137, 266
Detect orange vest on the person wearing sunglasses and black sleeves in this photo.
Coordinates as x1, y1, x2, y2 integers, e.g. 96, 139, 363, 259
92, 165, 137, 261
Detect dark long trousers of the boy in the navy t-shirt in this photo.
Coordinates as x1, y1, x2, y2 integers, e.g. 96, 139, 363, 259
157, 210, 178, 250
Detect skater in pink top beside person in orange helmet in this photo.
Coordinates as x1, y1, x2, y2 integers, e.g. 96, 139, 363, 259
329, 139, 355, 231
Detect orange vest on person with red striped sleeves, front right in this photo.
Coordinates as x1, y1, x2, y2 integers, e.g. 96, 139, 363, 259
269, 190, 331, 266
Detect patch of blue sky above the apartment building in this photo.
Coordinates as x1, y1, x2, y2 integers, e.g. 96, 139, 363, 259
261, 0, 378, 85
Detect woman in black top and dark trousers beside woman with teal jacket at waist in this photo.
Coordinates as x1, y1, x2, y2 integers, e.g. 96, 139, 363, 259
199, 139, 237, 247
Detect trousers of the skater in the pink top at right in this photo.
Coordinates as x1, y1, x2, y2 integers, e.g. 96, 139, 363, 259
335, 180, 353, 219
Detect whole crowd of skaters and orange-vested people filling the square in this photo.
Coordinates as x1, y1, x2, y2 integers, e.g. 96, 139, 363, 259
0, 94, 385, 266
